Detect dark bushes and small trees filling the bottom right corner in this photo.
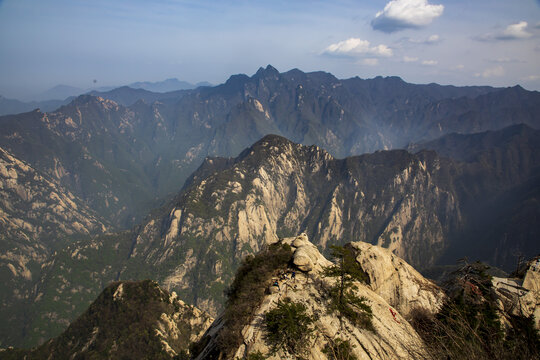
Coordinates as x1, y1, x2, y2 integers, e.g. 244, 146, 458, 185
410, 263, 540, 360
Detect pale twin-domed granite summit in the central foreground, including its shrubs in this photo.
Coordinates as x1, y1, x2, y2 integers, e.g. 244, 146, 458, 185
191, 234, 540, 360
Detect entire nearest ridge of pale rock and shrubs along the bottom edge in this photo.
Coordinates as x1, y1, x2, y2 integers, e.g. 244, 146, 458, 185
0, 234, 540, 360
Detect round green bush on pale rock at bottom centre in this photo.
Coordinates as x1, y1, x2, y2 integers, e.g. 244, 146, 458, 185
264, 298, 315, 358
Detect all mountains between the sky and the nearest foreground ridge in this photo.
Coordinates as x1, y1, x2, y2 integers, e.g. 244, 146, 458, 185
0, 66, 540, 346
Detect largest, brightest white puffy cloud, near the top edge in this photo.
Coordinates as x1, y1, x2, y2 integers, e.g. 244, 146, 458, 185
371, 0, 444, 33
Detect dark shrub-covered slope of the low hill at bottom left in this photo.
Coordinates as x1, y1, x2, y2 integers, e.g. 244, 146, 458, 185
17, 280, 177, 359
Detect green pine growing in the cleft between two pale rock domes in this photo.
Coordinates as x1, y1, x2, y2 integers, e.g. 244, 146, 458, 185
324, 245, 375, 331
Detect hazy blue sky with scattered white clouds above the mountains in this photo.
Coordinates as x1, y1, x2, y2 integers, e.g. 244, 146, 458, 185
0, 0, 540, 99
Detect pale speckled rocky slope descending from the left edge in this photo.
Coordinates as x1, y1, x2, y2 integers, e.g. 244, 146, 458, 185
0, 148, 106, 345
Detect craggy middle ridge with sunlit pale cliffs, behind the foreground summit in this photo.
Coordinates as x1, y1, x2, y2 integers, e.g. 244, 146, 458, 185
125, 129, 538, 313
